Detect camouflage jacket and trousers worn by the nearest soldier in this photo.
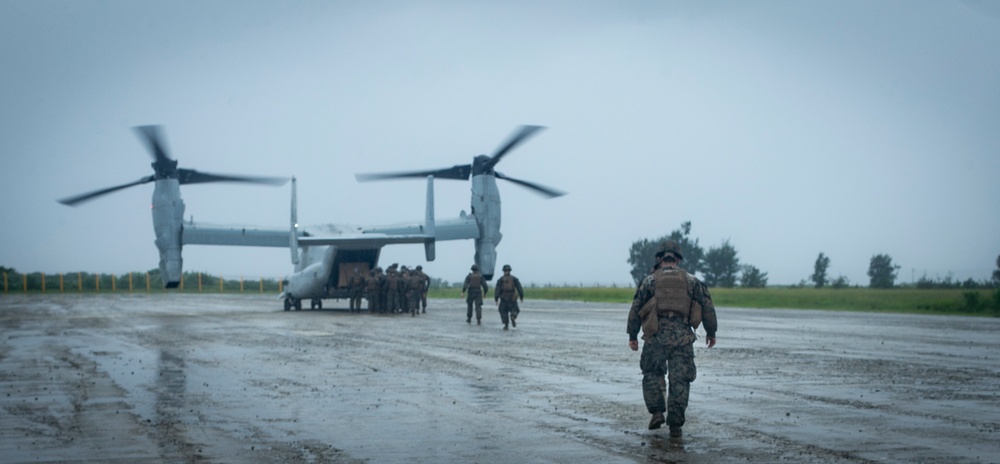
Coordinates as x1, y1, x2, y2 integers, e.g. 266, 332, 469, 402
627, 266, 718, 433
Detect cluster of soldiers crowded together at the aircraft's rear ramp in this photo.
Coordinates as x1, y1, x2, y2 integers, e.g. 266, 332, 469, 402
348, 263, 431, 316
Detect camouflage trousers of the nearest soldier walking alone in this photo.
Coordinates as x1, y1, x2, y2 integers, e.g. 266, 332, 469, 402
639, 338, 697, 425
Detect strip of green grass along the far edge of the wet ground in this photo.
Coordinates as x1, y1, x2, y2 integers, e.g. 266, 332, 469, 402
428, 287, 1000, 317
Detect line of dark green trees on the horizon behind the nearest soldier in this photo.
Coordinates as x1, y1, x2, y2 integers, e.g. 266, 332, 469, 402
627, 221, 1000, 289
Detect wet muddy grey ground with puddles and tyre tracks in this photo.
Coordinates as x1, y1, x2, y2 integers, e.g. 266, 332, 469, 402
0, 294, 1000, 464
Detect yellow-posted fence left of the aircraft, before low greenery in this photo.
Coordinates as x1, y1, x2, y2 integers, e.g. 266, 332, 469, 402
3, 272, 283, 293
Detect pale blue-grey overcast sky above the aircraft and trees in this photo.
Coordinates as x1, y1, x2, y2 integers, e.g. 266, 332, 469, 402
0, 0, 1000, 285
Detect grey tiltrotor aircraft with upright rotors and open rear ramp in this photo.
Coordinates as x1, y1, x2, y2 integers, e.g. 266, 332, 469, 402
59, 126, 564, 311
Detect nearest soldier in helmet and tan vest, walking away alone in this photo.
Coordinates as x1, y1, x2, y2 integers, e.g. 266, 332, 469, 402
626, 240, 718, 437
